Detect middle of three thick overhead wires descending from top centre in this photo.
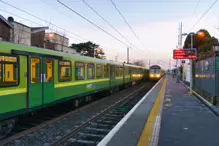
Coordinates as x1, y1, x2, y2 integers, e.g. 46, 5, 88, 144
82, 0, 139, 50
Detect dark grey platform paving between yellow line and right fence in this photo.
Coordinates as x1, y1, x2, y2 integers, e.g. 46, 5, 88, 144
158, 76, 219, 146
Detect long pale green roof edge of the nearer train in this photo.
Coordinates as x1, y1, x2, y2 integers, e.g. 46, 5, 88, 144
0, 41, 144, 68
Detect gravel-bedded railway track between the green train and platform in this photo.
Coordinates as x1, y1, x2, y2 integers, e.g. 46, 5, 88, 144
0, 83, 154, 146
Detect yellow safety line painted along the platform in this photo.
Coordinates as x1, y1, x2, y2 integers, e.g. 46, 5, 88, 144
138, 78, 166, 146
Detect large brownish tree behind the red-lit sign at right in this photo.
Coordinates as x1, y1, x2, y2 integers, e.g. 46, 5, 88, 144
183, 29, 218, 60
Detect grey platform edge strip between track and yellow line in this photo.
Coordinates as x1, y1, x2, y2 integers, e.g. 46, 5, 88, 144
98, 79, 163, 146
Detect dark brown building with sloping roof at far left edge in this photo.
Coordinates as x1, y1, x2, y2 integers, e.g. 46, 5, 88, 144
0, 15, 12, 41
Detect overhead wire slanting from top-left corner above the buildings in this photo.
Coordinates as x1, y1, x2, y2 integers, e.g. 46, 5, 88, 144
0, 0, 88, 41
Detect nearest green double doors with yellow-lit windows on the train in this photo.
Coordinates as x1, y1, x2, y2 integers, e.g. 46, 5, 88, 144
28, 56, 54, 108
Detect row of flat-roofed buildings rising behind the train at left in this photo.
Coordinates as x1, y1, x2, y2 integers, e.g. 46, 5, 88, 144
0, 15, 79, 54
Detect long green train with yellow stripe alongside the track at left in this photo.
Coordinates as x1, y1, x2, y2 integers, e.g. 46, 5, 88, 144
0, 42, 148, 136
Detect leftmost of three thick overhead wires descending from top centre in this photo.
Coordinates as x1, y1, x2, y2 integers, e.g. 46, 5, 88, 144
57, 0, 129, 47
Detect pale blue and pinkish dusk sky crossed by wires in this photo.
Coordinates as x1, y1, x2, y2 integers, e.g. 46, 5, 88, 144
0, 0, 219, 67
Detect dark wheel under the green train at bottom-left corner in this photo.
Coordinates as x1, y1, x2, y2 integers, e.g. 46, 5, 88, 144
0, 118, 17, 139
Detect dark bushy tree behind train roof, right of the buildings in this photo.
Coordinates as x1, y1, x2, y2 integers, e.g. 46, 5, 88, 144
70, 41, 106, 59
